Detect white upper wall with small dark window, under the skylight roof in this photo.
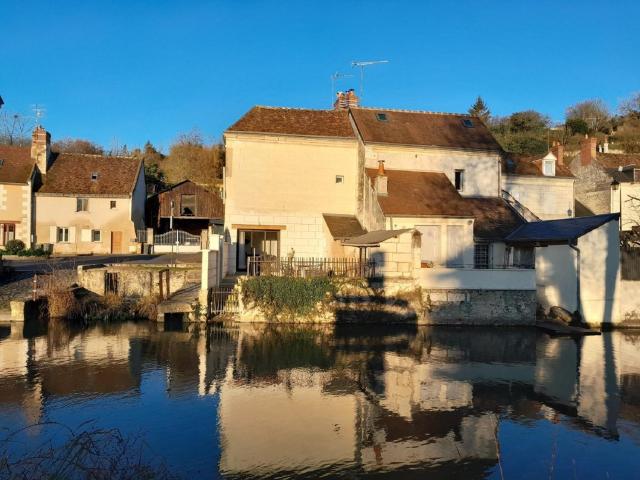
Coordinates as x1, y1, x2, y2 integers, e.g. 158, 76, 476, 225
365, 144, 501, 197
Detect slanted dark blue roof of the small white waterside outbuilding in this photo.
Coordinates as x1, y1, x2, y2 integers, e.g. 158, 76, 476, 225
506, 213, 620, 245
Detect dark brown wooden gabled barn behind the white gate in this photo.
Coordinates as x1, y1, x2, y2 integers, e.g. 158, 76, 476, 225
146, 180, 224, 235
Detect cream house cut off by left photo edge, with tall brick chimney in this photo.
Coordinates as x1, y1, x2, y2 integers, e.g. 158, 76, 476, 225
0, 126, 51, 247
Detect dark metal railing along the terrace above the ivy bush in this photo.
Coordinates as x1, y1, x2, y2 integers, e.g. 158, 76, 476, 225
247, 256, 375, 278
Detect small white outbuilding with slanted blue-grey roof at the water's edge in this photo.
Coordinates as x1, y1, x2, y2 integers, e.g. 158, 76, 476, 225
507, 213, 620, 326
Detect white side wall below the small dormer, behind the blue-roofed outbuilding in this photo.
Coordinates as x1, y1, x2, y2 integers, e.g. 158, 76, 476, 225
502, 175, 575, 220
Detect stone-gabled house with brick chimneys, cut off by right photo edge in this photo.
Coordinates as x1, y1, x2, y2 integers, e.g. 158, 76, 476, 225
570, 136, 640, 231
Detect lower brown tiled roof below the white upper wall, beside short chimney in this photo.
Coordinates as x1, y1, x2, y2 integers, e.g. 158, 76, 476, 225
367, 169, 524, 240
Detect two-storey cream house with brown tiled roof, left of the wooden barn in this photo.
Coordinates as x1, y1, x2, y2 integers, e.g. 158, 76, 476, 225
35, 149, 146, 254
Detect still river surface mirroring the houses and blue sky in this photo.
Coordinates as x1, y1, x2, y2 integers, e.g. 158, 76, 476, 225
0, 323, 640, 478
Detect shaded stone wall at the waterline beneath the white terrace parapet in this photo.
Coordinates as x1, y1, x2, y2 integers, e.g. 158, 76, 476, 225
421, 289, 536, 326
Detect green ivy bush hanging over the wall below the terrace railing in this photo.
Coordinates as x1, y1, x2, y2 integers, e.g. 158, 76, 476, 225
242, 276, 336, 315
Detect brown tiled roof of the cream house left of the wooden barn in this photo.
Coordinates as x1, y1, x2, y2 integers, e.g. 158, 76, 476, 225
38, 153, 142, 196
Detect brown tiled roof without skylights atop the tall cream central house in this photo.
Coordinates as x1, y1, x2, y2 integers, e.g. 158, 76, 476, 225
227, 106, 355, 138
